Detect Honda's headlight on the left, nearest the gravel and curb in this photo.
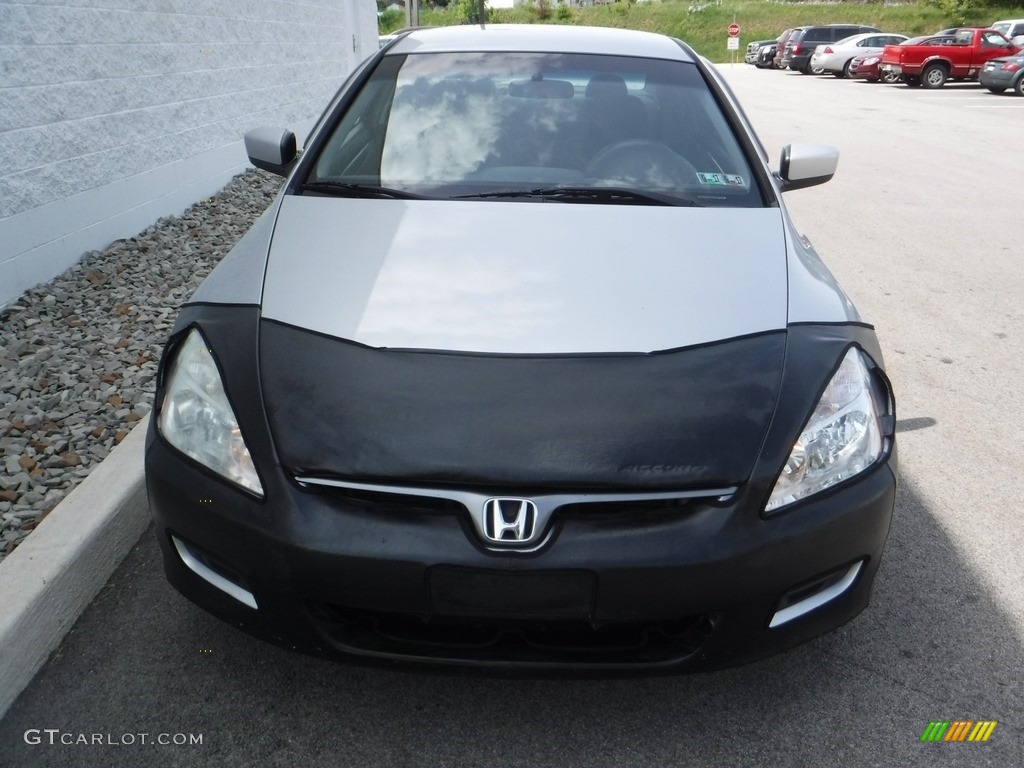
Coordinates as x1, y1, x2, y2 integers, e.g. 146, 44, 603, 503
157, 329, 263, 496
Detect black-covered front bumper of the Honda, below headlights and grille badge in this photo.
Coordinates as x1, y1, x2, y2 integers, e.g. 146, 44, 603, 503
145, 429, 896, 671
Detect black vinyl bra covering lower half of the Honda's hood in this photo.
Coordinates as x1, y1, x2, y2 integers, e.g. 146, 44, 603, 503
260, 321, 785, 489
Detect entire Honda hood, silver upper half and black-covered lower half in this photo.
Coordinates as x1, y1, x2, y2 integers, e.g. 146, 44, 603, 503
260, 199, 786, 493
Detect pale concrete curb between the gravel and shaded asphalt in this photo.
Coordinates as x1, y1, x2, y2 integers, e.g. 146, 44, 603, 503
0, 416, 150, 718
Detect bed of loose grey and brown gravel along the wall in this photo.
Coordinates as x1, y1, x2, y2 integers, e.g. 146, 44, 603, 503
0, 170, 283, 561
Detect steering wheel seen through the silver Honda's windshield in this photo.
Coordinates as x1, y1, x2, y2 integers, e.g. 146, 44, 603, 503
584, 138, 697, 187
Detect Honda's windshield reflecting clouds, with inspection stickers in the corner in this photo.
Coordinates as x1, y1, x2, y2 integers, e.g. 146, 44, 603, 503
305, 52, 765, 206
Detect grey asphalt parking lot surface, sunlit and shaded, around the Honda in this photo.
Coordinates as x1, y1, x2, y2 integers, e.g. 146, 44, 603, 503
0, 66, 1024, 768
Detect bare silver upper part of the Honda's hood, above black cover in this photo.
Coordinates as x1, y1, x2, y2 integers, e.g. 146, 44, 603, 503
262, 196, 787, 354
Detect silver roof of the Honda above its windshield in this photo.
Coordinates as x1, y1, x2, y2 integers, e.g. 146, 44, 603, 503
388, 24, 693, 61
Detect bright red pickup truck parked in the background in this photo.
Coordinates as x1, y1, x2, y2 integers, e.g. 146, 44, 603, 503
879, 28, 1020, 88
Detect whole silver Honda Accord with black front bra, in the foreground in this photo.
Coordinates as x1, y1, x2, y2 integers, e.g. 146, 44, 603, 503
145, 26, 896, 672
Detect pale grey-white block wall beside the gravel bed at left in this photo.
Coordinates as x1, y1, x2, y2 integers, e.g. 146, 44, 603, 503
0, 0, 377, 306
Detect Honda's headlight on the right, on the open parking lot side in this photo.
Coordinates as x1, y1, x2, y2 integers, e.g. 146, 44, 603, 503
765, 347, 886, 512
